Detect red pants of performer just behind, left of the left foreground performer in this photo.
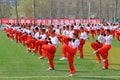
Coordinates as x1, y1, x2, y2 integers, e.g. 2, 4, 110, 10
34, 40, 46, 56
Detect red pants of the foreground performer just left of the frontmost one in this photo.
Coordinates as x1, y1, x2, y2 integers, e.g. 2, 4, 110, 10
42, 44, 56, 69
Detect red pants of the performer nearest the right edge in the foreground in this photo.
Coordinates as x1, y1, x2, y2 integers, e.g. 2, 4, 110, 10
98, 45, 111, 69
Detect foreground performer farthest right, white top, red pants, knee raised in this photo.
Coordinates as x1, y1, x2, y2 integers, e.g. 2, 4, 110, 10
94, 30, 113, 69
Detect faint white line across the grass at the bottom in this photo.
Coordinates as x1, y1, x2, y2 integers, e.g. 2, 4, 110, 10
0, 76, 120, 79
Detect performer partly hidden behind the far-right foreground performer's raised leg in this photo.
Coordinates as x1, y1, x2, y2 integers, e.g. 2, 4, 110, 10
90, 30, 104, 63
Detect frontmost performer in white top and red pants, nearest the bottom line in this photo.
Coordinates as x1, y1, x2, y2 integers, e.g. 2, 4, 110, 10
66, 32, 80, 77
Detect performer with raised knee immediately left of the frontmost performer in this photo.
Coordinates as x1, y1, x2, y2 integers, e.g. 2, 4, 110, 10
42, 30, 58, 70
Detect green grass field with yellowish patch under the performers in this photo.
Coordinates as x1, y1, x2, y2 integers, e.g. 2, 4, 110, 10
0, 31, 120, 80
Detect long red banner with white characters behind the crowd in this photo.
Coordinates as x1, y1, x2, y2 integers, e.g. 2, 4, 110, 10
2, 18, 101, 24
